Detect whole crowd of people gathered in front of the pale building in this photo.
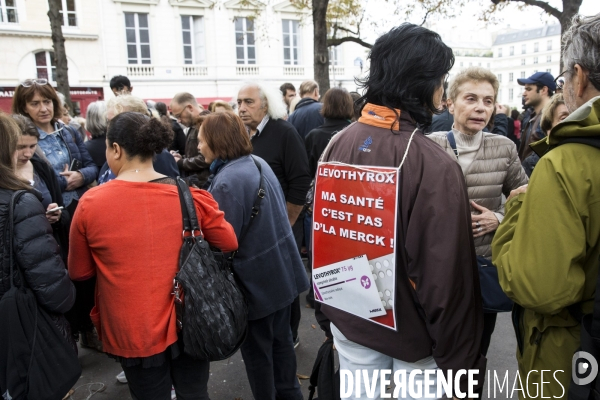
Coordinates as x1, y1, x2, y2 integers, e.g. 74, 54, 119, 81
0, 10, 600, 400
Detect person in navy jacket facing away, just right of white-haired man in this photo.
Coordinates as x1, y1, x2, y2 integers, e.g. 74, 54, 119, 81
288, 81, 325, 139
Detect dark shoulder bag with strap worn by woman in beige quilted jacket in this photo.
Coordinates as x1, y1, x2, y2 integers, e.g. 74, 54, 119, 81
446, 131, 513, 313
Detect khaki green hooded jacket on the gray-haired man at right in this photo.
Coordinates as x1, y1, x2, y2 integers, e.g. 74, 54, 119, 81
492, 97, 600, 399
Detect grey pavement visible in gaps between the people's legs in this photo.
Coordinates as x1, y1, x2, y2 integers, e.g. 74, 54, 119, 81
72, 282, 517, 400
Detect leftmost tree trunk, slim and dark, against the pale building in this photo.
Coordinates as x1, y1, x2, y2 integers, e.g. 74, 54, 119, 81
48, 0, 73, 111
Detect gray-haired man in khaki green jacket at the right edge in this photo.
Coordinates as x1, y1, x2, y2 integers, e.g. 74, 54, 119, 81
492, 14, 600, 400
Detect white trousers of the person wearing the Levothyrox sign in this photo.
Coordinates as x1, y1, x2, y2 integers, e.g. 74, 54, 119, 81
331, 324, 446, 400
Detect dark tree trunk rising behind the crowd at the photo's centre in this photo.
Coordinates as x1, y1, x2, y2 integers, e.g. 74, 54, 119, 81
312, 0, 329, 94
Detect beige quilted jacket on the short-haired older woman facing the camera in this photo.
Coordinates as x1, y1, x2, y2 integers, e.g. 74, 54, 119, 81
427, 132, 529, 258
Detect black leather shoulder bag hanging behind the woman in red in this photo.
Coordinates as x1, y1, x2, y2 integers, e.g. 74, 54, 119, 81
173, 158, 265, 361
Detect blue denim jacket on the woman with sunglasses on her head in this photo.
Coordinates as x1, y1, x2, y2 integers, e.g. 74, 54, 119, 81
38, 122, 98, 207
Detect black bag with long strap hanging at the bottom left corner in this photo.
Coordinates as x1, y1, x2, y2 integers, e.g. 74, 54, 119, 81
0, 191, 81, 400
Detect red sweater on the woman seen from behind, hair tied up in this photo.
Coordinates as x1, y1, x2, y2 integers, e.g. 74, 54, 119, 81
69, 180, 237, 357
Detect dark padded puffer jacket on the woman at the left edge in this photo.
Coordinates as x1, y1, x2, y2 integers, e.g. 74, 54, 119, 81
0, 189, 75, 313
